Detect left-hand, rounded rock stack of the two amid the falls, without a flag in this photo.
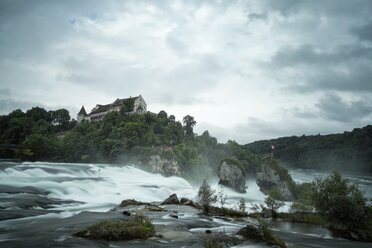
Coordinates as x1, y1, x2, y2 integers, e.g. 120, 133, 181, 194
217, 161, 246, 193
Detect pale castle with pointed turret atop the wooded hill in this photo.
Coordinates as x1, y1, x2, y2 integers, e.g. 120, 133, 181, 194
77, 95, 147, 122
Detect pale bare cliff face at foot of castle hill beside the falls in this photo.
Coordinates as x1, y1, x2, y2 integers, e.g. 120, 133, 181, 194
149, 155, 181, 177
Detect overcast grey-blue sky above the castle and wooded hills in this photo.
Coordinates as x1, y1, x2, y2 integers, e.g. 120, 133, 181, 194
0, 0, 372, 144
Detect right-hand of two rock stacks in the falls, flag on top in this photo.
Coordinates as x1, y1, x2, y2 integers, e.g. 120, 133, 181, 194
256, 162, 294, 201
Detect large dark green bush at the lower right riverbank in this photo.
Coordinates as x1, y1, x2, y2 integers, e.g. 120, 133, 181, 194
313, 172, 369, 230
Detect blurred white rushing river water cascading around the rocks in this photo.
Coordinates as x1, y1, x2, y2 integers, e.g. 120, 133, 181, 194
0, 162, 372, 247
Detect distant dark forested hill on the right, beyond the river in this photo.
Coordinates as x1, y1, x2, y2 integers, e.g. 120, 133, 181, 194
245, 125, 372, 174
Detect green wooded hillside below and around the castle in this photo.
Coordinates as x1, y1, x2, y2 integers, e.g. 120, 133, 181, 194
0, 107, 259, 180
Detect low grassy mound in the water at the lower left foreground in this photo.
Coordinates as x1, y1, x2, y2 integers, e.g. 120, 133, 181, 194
74, 215, 155, 241
